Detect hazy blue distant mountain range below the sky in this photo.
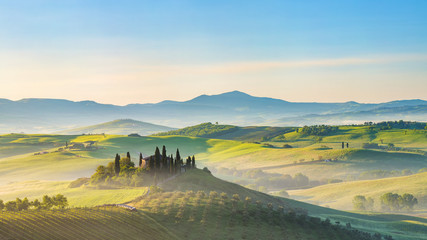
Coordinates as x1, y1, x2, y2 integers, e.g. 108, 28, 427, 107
0, 91, 427, 133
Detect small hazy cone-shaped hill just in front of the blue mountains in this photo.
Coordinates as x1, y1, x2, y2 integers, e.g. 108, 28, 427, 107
58, 119, 174, 136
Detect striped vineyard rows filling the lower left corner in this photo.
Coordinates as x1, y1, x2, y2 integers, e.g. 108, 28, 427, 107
0, 208, 178, 240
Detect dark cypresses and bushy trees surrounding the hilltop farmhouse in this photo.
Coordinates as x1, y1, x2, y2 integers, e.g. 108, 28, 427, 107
90, 146, 196, 186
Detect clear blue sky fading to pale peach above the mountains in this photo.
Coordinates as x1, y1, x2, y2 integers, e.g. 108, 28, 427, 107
0, 0, 427, 105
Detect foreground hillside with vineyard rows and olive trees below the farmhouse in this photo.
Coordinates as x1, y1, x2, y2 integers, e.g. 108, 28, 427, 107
0, 169, 427, 240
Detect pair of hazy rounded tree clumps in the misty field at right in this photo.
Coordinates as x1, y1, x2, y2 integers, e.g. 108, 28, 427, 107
353, 193, 418, 211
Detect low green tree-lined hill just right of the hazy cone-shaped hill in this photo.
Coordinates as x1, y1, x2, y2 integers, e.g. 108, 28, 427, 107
155, 123, 293, 141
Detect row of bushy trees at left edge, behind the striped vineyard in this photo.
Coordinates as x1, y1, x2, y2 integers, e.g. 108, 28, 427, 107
0, 194, 68, 211
